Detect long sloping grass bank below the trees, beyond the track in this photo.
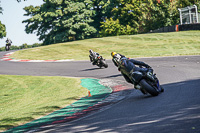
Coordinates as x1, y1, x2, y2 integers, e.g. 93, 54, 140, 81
11, 31, 200, 60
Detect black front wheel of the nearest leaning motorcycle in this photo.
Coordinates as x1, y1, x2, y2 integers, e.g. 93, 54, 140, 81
140, 79, 159, 96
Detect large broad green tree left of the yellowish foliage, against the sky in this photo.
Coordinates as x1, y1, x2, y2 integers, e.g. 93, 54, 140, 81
23, 0, 96, 44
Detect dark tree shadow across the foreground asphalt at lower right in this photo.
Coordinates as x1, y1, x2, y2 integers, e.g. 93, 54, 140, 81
45, 79, 200, 133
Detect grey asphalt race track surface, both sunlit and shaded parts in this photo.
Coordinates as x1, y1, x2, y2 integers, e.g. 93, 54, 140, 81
0, 52, 200, 133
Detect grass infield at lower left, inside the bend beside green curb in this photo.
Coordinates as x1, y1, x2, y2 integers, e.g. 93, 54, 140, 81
0, 75, 87, 131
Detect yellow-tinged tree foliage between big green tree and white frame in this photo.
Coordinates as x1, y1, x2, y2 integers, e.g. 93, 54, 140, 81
100, 0, 199, 36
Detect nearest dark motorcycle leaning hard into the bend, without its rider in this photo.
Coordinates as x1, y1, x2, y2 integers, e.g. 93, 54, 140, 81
130, 66, 164, 96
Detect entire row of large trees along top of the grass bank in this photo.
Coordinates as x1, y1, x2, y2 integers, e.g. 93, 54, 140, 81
18, 0, 200, 44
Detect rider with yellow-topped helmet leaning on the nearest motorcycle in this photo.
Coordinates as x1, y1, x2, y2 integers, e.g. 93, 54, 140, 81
111, 52, 153, 89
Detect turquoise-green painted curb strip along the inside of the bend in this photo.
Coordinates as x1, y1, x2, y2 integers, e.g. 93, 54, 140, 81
5, 78, 112, 133
